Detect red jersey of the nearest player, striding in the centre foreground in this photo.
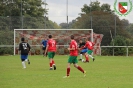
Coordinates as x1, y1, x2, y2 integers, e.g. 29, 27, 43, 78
69, 40, 78, 56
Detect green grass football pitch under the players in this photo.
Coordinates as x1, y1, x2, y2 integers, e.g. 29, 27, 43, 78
0, 55, 133, 88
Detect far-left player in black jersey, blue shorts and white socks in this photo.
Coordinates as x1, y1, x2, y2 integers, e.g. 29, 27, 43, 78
19, 38, 31, 68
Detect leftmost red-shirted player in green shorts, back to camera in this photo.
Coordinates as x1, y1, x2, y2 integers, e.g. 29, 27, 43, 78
45, 35, 56, 70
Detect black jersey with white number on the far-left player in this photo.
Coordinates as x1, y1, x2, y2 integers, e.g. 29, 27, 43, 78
19, 42, 31, 55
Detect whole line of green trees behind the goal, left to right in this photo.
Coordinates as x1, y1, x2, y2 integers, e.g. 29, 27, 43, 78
0, 0, 133, 55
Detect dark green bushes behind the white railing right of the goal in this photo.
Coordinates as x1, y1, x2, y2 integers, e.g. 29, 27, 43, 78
102, 36, 133, 56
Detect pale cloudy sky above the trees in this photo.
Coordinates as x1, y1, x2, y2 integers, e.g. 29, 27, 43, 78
43, 0, 133, 24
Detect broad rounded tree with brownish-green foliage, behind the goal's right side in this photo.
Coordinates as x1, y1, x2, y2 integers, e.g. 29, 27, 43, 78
72, 1, 131, 45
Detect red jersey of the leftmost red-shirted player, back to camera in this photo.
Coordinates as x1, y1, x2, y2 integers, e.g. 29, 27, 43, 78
47, 39, 56, 52
